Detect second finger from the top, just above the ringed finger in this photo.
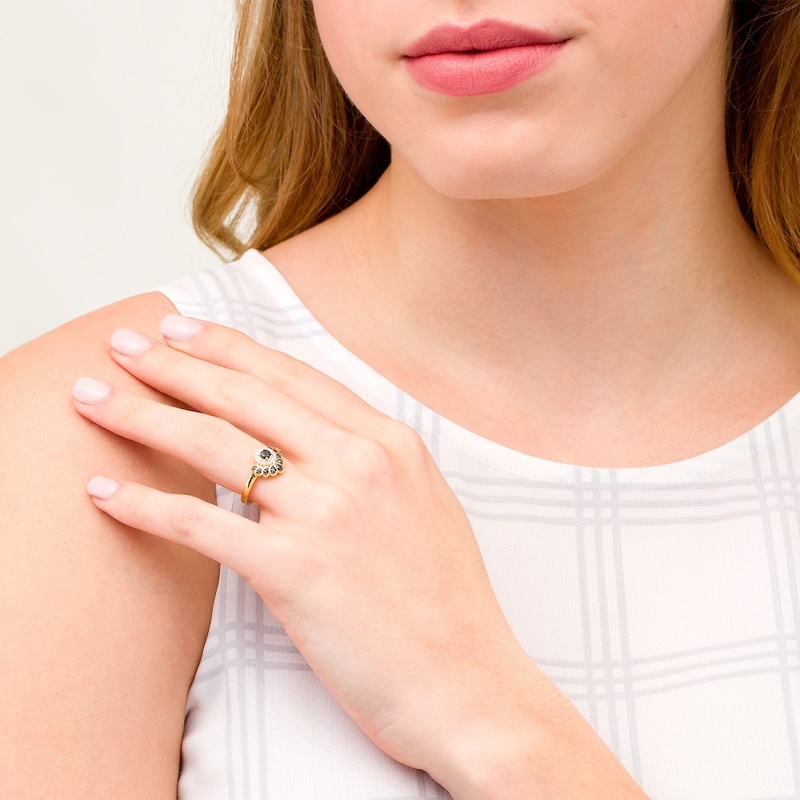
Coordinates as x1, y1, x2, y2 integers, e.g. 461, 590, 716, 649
104, 331, 382, 460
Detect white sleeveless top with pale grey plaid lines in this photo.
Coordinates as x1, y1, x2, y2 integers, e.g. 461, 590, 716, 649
159, 251, 800, 800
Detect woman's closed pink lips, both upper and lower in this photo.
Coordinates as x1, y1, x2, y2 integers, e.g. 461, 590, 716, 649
405, 20, 568, 97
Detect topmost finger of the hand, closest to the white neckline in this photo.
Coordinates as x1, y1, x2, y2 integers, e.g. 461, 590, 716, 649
156, 314, 384, 433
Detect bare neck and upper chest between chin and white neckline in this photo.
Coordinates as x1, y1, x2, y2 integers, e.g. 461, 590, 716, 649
266, 56, 800, 465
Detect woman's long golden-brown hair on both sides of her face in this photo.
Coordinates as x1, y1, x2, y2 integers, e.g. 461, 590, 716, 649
192, 0, 800, 283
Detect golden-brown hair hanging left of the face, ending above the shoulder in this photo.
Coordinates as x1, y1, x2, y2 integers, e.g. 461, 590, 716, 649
192, 0, 389, 256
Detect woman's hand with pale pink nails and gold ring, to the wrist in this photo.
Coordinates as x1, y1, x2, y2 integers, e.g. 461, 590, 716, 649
76, 317, 532, 782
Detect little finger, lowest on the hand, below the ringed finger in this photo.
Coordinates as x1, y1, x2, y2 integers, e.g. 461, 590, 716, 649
87, 476, 280, 582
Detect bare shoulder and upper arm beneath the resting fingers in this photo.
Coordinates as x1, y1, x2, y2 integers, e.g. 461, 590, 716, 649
0, 293, 217, 799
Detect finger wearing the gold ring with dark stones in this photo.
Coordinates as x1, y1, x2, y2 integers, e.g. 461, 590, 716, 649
73, 378, 309, 514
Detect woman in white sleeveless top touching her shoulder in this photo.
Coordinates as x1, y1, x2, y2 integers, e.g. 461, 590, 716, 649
3, 0, 800, 800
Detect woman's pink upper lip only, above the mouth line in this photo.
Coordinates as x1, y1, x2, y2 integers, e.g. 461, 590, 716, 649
405, 20, 569, 58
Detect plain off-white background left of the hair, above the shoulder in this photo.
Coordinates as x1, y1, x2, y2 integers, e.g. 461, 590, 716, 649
0, 0, 234, 354
